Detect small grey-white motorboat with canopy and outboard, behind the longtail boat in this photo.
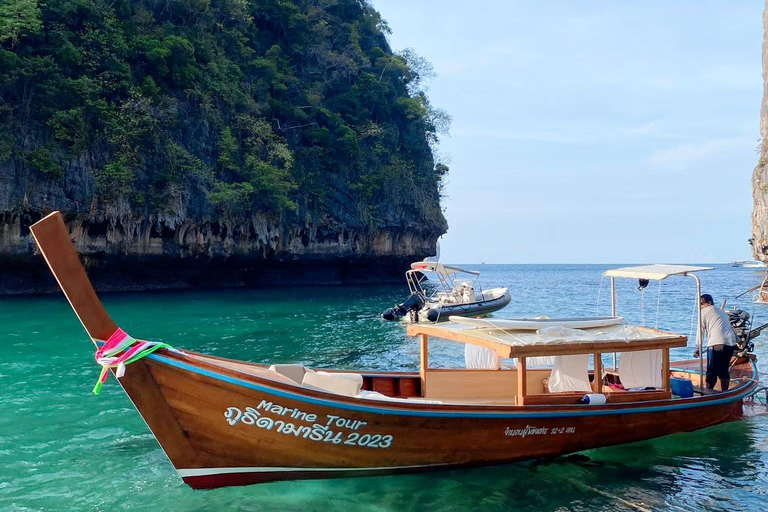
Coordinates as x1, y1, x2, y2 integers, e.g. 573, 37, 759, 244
381, 260, 511, 323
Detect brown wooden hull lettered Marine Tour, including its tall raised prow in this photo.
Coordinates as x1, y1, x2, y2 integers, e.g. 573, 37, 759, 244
31, 213, 757, 488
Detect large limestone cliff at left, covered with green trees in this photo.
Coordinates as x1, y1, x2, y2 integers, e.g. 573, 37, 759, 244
0, 0, 449, 293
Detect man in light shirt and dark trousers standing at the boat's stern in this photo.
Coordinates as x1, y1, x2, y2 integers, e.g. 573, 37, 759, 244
694, 293, 738, 391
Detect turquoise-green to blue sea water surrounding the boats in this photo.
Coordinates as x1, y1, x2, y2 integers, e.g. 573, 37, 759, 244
0, 265, 768, 512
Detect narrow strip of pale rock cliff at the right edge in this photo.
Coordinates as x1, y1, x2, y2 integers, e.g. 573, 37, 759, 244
749, 0, 768, 261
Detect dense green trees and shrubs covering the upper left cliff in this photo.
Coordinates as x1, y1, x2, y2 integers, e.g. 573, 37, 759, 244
0, 0, 448, 227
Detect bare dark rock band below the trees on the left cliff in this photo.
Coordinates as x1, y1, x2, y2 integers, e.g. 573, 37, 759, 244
0, 154, 446, 294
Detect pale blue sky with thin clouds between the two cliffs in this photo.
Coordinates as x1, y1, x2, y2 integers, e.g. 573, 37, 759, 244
372, 0, 763, 263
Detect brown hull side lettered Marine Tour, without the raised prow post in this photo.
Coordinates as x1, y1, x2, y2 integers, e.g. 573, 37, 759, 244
126, 354, 753, 489
